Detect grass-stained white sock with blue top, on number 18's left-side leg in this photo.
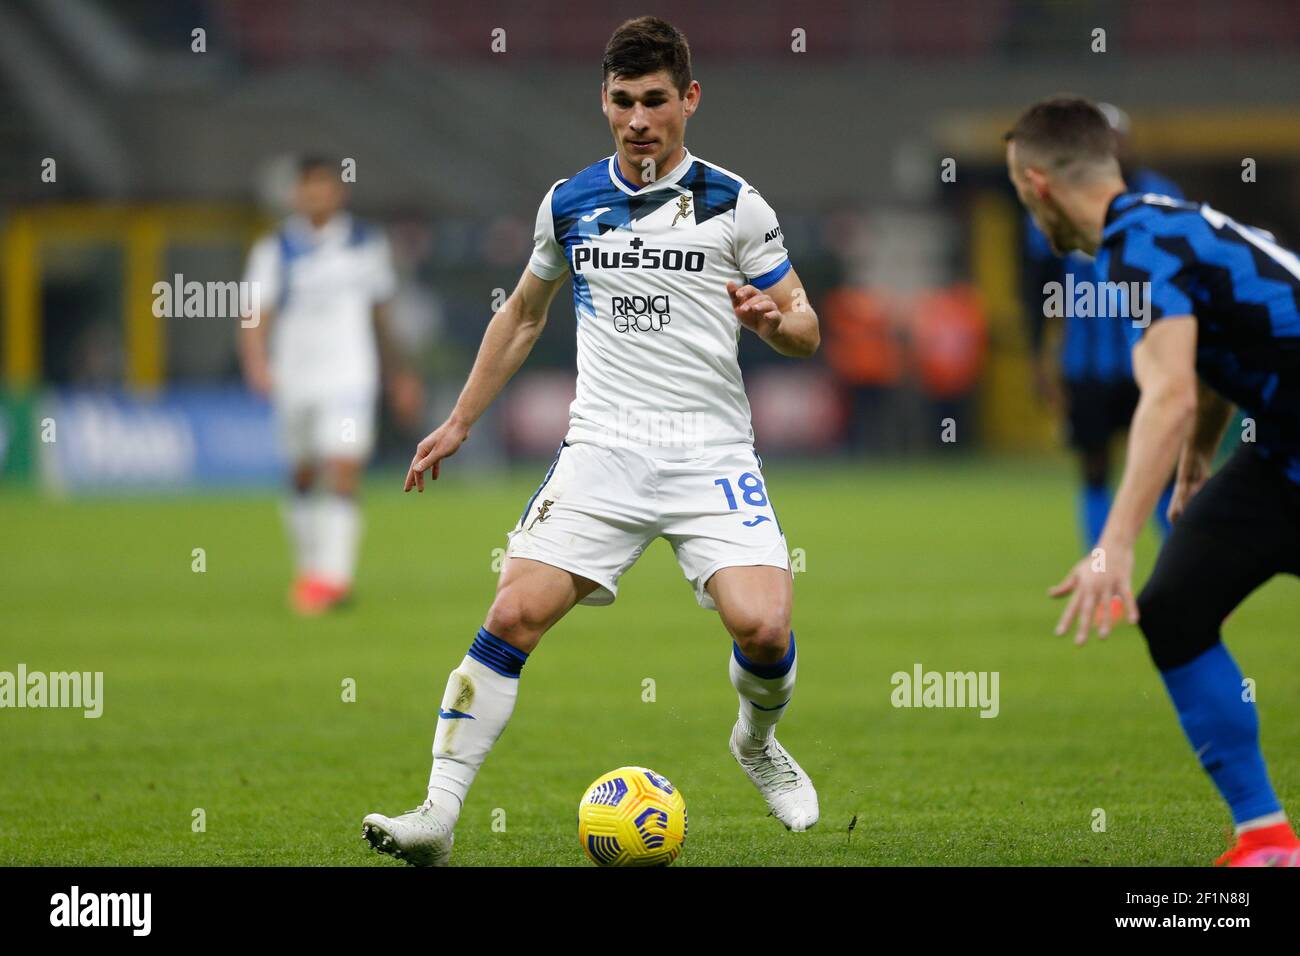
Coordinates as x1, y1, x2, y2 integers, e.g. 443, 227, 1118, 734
429, 628, 528, 823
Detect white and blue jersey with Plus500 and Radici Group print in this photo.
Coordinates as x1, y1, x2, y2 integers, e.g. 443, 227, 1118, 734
529, 151, 790, 449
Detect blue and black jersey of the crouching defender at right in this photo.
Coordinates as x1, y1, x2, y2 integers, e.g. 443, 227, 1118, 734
1097, 193, 1300, 483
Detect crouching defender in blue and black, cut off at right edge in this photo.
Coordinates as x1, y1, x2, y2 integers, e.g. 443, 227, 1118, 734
1006, 98, 1300, 866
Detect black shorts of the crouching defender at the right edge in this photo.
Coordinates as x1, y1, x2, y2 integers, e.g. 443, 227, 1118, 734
1138, 446, 1300, 671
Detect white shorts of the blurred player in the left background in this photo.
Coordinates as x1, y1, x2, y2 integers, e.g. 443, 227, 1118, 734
274, 392, 374, 464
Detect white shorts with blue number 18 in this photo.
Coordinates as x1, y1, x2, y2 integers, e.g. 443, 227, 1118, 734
506, 442, 790, 610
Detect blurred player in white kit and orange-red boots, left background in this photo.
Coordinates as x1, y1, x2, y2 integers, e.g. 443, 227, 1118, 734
239, 157, 424, 614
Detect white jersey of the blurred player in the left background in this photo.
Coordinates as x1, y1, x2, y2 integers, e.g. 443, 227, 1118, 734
244, 212, 397, 401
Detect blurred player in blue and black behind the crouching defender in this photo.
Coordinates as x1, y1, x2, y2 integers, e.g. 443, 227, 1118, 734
1022, 103, 1183, 548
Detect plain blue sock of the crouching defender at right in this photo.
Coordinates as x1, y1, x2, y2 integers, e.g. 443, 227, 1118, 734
1161, 643, 1282, 823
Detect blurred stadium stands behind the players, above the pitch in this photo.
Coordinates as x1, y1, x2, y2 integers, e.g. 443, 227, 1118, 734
0, 0, 1300, 489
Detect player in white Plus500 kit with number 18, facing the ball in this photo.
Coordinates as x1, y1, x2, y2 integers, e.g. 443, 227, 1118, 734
363, 17, 820, 865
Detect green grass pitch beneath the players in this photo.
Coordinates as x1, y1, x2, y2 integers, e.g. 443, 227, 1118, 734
0, 462, 1300, 866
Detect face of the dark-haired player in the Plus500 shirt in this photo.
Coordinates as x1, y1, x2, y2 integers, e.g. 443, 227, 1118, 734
601, 70, 699, 179
